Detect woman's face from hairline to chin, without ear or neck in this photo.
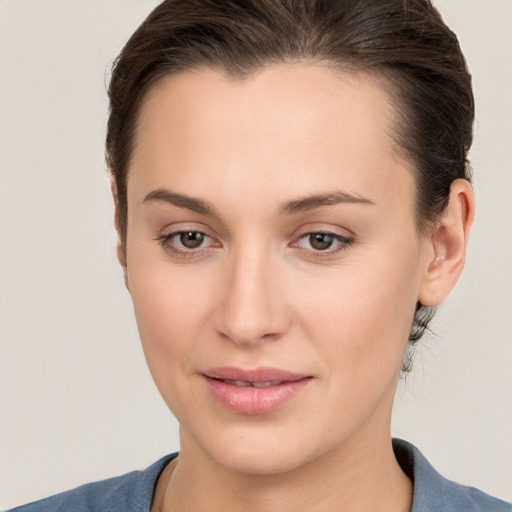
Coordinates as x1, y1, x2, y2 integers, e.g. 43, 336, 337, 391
126, 64, 427, 474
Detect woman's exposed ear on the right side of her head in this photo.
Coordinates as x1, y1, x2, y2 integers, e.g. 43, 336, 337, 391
418, 179, 475, 306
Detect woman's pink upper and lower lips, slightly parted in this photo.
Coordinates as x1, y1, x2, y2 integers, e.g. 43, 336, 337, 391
203, 367, 312, 415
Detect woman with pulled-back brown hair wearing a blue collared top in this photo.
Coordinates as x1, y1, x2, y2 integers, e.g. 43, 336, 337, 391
6, 0, 510, 512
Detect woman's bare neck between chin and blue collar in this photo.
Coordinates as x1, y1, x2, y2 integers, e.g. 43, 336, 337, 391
153, 432, 412, 512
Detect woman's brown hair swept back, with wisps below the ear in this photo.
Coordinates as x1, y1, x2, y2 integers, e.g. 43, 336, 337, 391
106, 0, 474, 356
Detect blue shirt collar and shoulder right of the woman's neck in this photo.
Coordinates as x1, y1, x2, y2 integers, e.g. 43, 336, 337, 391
393, 439, 512, 512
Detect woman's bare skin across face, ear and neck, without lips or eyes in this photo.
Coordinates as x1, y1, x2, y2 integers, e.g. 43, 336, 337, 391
114, 63, 474, 512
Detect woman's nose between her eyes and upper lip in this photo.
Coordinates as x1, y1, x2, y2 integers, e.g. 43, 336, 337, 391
215, 245, 290, 347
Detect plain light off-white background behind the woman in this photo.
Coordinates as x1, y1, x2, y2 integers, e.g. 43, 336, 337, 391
0, 0, 512, 508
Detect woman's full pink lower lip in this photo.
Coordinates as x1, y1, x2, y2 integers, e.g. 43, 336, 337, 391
205, 376, 311, 416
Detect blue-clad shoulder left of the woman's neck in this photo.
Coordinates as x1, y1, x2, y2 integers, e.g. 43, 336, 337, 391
8, 453, 177, 512
